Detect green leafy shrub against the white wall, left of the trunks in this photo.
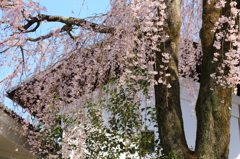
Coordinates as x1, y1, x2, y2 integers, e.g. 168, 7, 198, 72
82, 62, 163, 159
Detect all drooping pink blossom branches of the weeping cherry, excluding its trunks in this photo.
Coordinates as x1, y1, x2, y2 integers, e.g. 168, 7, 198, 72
0, 0, 240, 158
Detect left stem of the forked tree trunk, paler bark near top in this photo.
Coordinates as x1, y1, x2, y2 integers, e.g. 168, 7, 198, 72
154, 0, 195, 159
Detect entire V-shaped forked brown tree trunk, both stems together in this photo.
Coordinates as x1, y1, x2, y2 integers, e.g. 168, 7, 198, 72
154, 0, 232, 159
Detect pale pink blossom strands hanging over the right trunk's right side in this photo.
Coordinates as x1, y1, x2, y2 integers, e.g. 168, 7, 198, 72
211, 1, 240, 87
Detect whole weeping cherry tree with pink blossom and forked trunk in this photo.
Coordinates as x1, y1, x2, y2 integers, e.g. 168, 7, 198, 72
0, 0, 240, 159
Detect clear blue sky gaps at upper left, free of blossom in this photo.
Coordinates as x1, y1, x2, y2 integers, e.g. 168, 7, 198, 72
0, 0, 110, 111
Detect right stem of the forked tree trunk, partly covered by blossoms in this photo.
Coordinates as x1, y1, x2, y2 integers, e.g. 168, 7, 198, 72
195, 0, 232, 159
